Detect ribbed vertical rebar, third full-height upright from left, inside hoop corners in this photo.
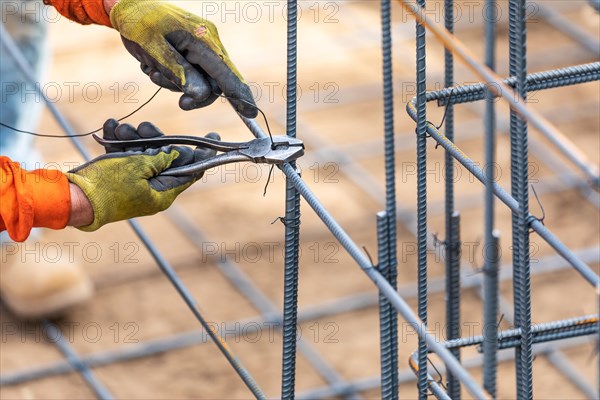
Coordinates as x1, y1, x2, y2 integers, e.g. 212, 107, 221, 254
416, 0, 428, 400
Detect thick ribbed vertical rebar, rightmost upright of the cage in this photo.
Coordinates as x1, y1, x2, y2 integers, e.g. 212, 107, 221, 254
509, 0, 533, 399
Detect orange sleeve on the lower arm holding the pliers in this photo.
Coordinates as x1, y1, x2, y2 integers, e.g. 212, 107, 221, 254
0, 156, 71, 242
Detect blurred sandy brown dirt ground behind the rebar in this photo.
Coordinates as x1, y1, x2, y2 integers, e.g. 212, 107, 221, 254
0, 0, 600, 399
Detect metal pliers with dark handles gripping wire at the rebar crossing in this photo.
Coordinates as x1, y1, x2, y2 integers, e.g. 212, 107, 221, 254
92, 135, 304, 176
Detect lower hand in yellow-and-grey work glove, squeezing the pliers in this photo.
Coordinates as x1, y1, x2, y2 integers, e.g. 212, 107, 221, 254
66, 120, 220, 232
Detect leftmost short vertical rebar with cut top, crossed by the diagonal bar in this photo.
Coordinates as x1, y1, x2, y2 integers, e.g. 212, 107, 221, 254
377, 211, 398, 399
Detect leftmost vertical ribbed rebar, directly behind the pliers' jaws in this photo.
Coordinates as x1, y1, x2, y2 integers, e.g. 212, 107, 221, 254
281, 0, 300, 399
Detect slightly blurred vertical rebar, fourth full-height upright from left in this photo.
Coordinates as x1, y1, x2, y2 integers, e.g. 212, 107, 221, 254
444, 0, 460, 400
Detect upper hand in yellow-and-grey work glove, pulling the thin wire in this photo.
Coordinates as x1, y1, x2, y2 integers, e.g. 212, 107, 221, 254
110, 0, 258, 118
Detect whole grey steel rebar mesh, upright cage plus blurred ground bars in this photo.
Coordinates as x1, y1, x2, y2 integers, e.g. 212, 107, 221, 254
0, 0, 600, 399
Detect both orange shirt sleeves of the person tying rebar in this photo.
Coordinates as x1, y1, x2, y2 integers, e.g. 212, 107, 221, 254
0, 0, 111, 242
